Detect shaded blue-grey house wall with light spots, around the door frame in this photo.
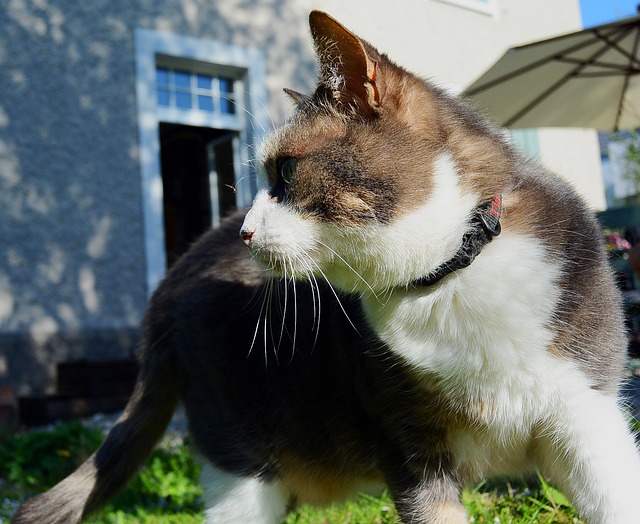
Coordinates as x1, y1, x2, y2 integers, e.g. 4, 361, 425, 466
0, 0, 315, 394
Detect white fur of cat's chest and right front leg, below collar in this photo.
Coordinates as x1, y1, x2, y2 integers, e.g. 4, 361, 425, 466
364, 226, 640, 524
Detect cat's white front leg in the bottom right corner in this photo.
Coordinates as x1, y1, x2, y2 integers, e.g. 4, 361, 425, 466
535, 380, 640, 524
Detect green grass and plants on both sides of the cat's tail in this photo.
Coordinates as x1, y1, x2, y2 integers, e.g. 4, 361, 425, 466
0, 422, 202, 524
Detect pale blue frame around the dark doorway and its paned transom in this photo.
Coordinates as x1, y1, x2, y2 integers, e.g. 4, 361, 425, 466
135, 28, 270, 296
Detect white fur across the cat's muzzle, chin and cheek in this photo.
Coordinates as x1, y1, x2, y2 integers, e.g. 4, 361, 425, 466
242, 154, 478, 292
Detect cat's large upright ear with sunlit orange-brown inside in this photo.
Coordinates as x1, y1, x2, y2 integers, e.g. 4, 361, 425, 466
309, 11, 383, 117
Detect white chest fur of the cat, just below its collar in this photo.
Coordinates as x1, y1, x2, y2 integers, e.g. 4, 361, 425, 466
364, 233, 565, 427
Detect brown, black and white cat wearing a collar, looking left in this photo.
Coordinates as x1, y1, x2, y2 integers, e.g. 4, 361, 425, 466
13, 11, 640, 524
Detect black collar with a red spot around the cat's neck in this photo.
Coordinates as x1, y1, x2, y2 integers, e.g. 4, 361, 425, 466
410, 194, 502, 287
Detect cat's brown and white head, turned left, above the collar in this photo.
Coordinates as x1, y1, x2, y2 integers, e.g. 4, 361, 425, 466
241, 11, 508, 292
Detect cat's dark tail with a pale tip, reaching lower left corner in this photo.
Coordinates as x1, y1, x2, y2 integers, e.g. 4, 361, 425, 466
11, 340, 182, 524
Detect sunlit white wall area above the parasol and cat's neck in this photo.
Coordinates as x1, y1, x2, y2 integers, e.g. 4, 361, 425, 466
304, 0, 581, 89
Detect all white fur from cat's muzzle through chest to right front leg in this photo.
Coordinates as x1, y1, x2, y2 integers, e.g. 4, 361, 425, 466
242, 149, 640, 524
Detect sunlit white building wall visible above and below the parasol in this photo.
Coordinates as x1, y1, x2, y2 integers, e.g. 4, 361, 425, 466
304, 0, 605, 209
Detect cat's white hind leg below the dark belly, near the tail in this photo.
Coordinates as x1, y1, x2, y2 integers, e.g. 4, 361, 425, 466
200, 462, 286, 524
